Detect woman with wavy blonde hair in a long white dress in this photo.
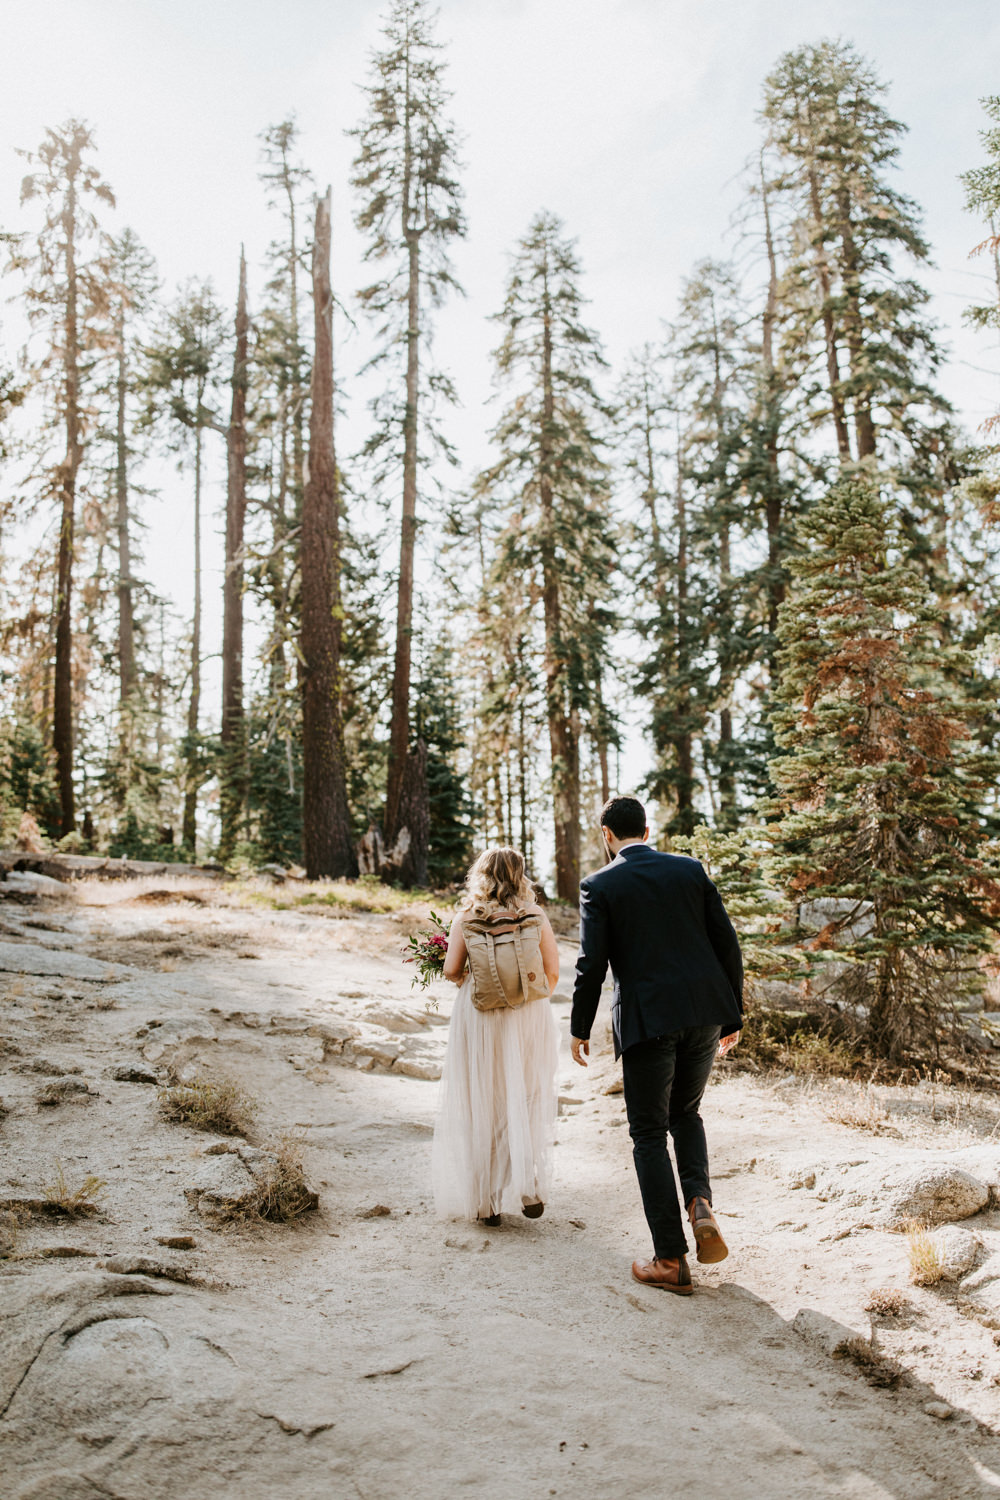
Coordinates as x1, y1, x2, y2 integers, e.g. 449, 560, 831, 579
432, 849, 559, 1227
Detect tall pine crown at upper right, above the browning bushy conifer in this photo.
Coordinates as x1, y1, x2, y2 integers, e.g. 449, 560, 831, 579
763, 42, 949, 489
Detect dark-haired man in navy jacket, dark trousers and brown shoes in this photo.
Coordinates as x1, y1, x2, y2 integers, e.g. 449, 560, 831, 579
570, 797, 744, 1296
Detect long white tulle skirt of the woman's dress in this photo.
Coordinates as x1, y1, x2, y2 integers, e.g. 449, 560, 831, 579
432, 980, 559, 1220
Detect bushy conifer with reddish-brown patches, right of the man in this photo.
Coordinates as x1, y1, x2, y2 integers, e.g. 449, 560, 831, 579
769, 473, 1000, 1061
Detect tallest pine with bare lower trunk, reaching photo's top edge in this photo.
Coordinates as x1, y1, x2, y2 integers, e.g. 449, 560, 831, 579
352, 0, 465, 885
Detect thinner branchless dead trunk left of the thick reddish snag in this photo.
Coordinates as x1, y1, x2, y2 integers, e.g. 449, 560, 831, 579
219, 252, 250, 863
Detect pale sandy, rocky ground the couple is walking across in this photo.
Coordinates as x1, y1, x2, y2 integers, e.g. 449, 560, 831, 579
0, 876, 1000, 1500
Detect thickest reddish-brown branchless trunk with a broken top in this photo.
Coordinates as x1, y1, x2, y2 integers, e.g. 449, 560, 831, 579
301, 189, 358, 881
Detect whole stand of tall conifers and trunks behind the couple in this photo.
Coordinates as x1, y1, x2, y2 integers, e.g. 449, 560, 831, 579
0, 0, 1000, 1056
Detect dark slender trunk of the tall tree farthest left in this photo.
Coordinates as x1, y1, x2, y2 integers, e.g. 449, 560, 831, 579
52, 159, 82, 836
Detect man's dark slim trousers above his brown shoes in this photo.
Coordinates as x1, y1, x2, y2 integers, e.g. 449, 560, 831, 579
622, 1026, 721, 1260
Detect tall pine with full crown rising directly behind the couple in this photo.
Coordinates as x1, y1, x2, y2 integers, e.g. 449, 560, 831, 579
483, 213, 616, 900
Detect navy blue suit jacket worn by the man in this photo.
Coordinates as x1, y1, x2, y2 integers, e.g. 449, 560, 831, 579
571, 843, 744, 1058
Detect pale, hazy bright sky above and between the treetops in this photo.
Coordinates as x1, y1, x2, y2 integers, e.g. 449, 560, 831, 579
0, 0, 1000, 810
